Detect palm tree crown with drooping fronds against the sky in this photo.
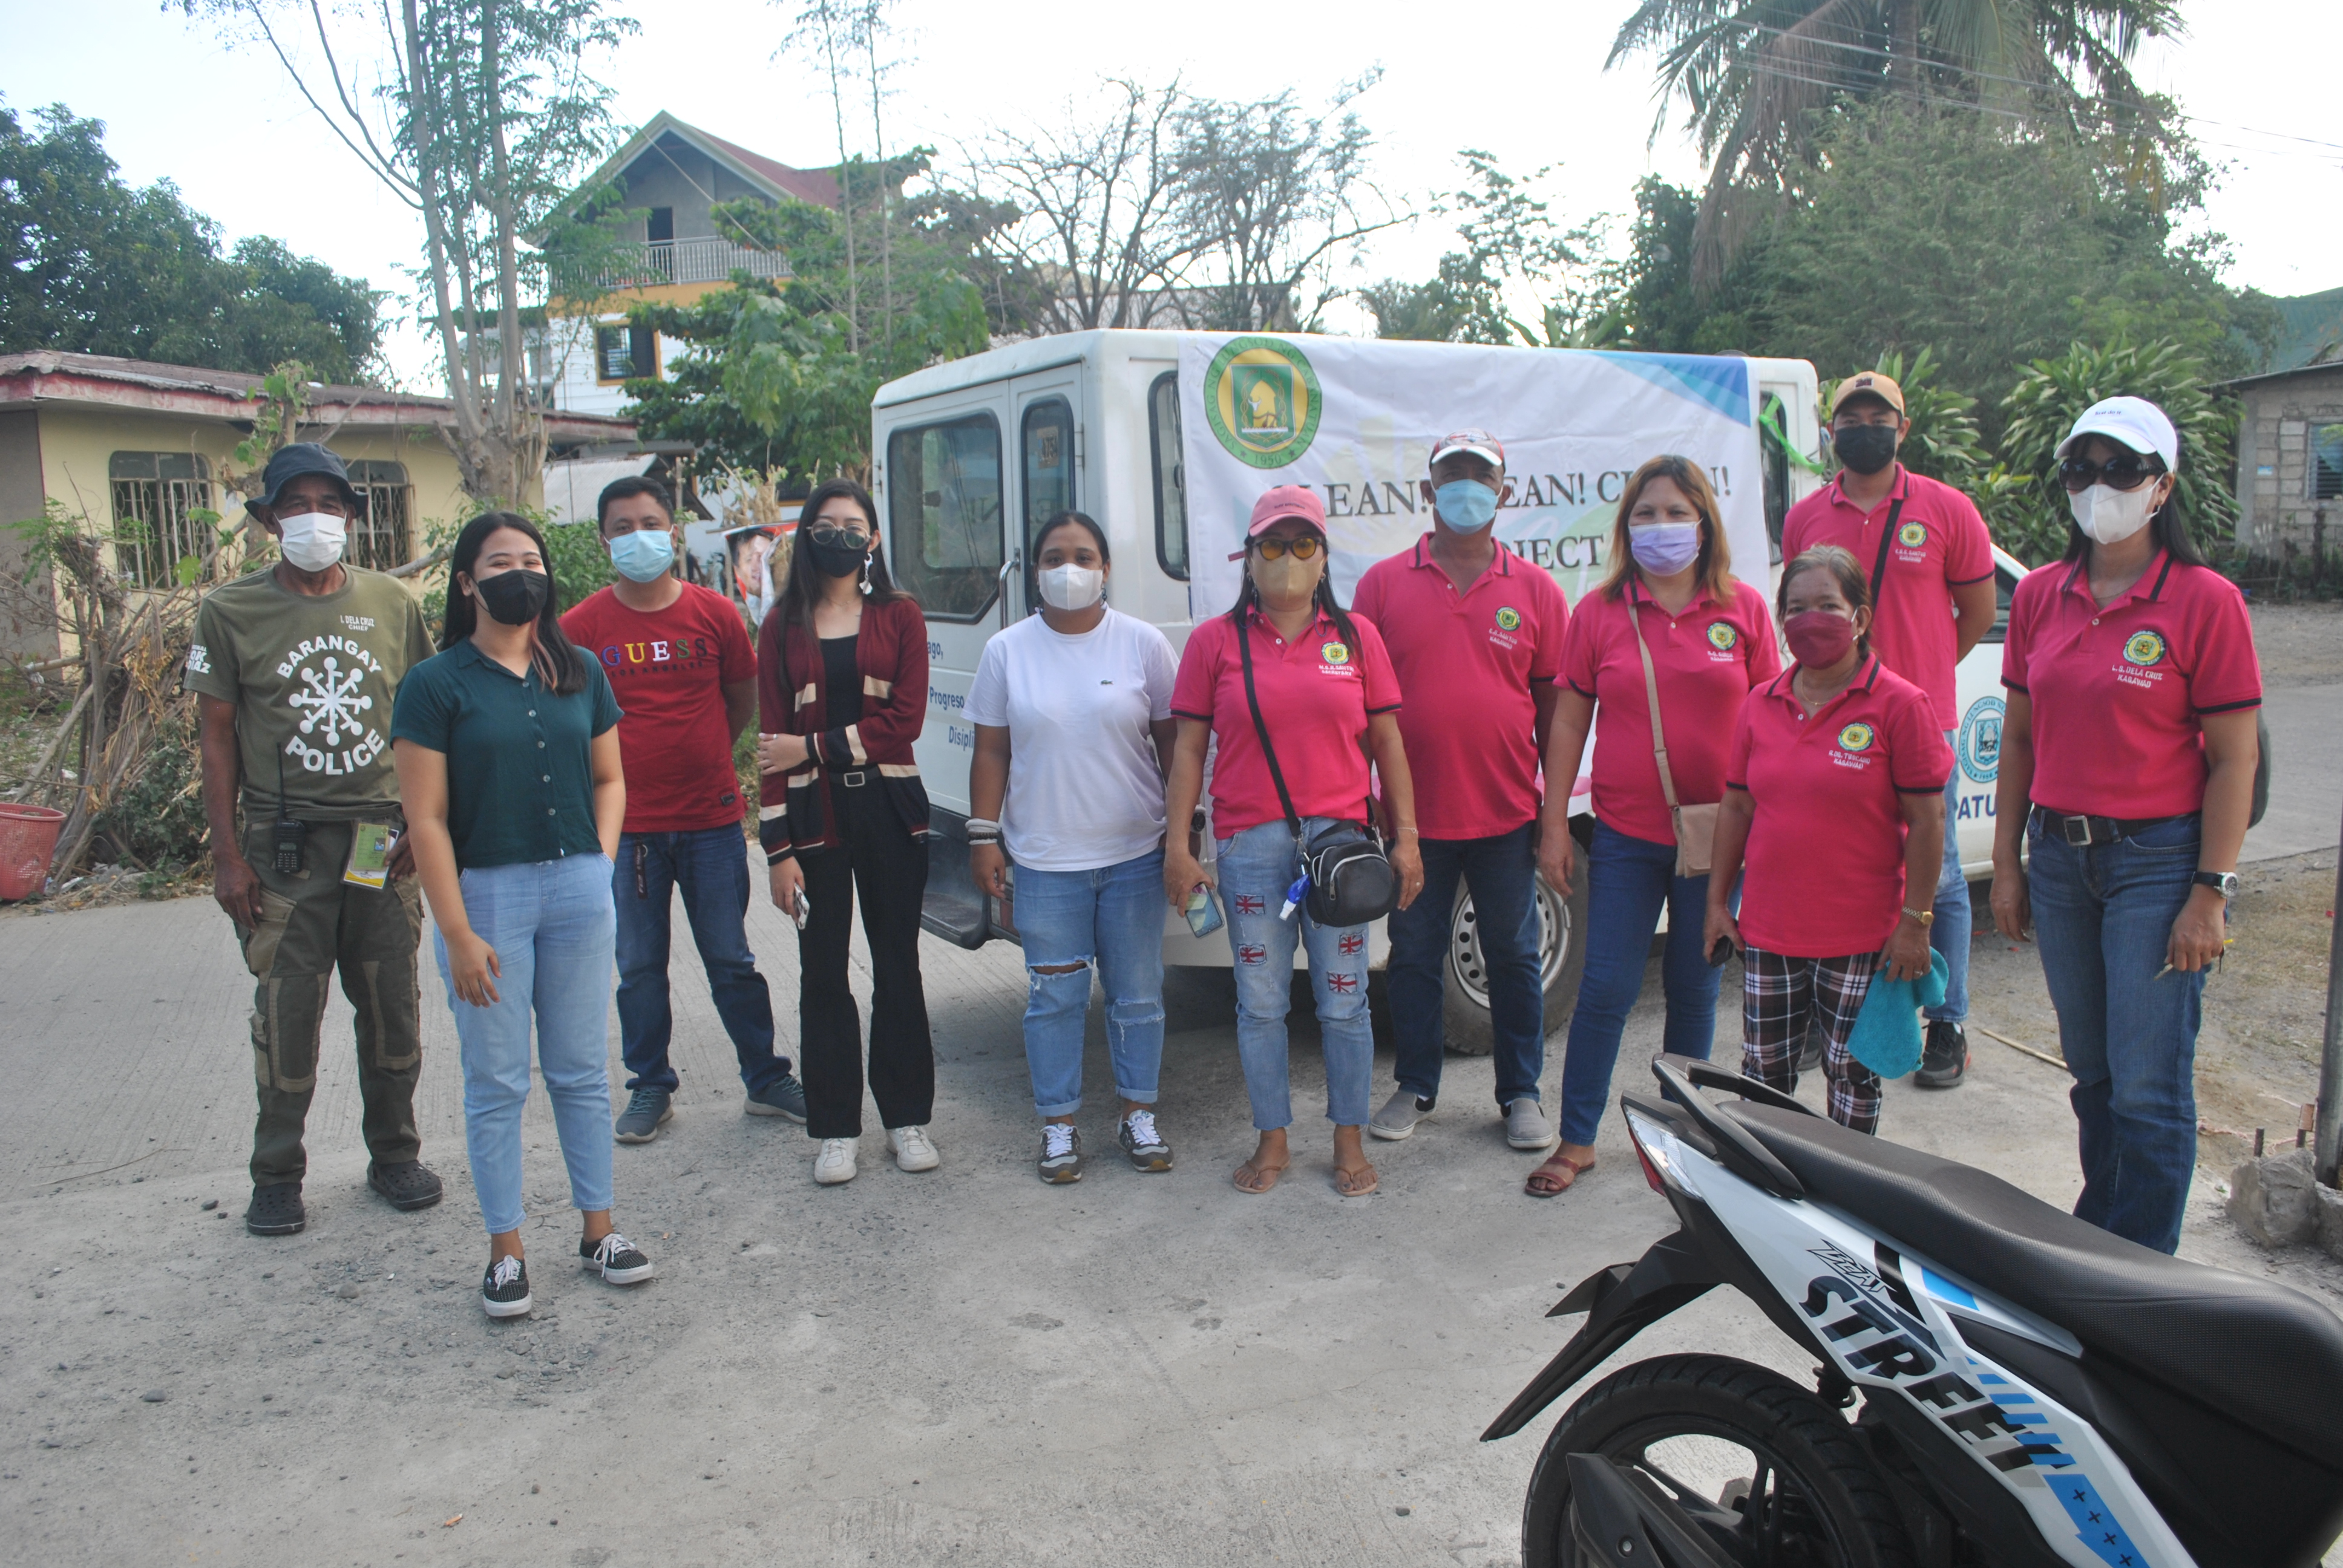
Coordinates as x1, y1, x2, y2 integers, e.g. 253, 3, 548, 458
1605, 0, 2181, 290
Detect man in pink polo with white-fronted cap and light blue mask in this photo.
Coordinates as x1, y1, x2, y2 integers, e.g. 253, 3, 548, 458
1352, 431, 1570, 1148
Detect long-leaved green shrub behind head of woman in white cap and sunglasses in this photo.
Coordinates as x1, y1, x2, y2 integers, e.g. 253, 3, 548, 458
1989, 342, 2238, 563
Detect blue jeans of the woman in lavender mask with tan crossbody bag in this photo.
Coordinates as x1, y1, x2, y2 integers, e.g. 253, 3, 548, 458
1563, 823, 1722, 1148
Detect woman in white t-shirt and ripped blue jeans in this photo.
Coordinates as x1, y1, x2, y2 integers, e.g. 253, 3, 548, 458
968, 511, 1179, 1184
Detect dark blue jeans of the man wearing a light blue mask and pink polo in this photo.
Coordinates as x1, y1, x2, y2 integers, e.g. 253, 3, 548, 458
1387, 823, 1547, 1109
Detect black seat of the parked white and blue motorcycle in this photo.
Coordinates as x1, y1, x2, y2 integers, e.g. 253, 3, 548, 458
1720, 1102, 2343, 1472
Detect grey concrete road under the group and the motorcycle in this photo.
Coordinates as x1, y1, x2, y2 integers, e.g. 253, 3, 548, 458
0, 867, 2343, 1568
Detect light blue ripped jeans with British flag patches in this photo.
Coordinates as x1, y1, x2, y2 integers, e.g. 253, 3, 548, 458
1218, 815, 1375, 1132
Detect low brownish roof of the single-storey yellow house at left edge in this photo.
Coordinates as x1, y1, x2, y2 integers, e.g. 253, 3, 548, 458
0, 349, 635, 448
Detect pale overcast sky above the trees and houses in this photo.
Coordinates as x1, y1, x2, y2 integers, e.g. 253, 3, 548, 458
0, 0, 2343, 384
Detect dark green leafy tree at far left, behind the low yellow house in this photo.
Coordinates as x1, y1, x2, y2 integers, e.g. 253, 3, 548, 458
0, 105, 384, 382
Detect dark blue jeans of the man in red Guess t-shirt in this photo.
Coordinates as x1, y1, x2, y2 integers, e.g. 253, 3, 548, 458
612, 825, 790, 1094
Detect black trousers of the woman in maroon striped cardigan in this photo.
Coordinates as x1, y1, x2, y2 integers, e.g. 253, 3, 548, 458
796, 769, 935, 1137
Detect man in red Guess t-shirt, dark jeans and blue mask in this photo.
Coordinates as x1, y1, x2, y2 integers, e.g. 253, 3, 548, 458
562, 478, 806, 1144
